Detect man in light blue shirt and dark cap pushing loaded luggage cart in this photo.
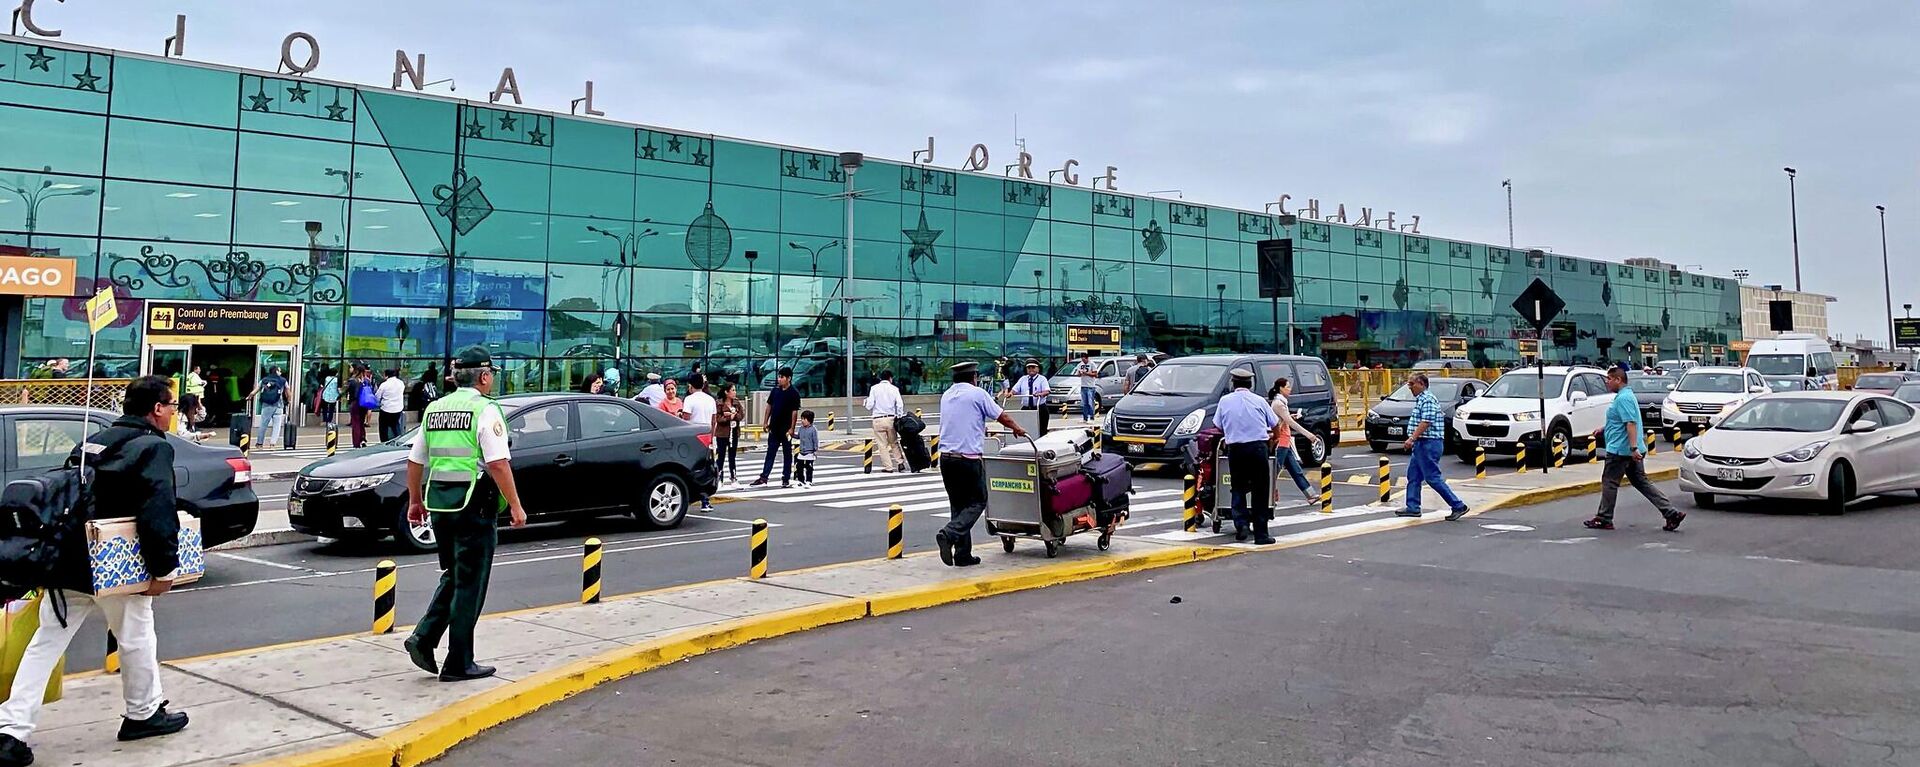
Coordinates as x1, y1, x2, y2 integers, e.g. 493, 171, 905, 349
933, 361, 1027, 567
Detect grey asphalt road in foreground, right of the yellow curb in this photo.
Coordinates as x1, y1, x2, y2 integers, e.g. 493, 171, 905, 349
440, 486, 1920, 767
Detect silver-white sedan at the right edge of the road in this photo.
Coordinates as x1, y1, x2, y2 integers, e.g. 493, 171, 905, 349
1680, 392, 1920, 513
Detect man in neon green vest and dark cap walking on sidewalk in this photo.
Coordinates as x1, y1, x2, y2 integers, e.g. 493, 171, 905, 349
407, 346, 526, 682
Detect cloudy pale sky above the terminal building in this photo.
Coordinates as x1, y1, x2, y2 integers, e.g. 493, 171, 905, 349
38, 0, 1920, 338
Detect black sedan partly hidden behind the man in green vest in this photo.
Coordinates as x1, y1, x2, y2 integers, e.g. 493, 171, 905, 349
286, 394, 718, 550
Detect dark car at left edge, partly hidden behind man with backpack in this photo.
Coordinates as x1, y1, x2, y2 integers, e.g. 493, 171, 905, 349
0, 406, 259, 548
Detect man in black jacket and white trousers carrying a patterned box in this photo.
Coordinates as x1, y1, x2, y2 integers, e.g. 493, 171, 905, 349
0, 375, 186, 767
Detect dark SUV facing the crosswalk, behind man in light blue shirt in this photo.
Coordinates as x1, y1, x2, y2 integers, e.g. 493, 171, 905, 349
1100, 354, 1340, 465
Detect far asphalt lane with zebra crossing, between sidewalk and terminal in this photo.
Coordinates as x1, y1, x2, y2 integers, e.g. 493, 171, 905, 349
52, 448, 1474, 671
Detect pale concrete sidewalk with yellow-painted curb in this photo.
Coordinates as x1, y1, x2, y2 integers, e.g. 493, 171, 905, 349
31, 454, 1678, 767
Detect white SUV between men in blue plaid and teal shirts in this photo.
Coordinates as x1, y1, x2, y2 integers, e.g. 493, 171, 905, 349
1453, 367, 1613, 461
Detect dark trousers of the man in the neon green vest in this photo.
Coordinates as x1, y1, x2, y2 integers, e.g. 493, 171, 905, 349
413, 492, 499, 669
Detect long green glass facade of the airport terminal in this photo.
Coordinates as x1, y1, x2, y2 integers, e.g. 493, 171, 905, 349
0, 38, 1740, 394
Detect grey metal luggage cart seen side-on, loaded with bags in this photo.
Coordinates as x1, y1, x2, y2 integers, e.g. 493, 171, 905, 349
981, 436, 1127, 557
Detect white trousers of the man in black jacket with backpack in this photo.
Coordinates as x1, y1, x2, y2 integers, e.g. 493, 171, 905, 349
0, 592, 161, 742
